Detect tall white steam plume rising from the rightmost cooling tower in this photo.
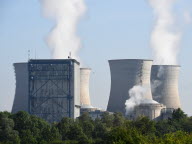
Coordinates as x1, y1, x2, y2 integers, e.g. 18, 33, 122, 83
149, 0, 181, 65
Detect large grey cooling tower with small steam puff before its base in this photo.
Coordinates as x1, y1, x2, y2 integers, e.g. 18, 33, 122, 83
107, 59, 152, 114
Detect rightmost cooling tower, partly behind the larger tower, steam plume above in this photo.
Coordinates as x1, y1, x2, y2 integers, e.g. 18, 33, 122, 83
151, 65, 181, 109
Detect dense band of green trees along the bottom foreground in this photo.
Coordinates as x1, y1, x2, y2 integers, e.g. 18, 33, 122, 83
0, 109, 192, 144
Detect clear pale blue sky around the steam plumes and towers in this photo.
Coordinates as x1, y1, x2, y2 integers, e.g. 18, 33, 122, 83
0, 0, 192, 116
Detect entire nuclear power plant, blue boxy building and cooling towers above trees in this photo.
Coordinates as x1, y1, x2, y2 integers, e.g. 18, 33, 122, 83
12, 59, 181, 122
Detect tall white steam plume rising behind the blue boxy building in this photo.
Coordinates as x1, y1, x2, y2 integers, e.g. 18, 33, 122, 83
39, 0, 86, 59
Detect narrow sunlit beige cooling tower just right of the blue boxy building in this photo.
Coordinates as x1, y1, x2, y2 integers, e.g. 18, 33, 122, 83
80, 68, 91, 106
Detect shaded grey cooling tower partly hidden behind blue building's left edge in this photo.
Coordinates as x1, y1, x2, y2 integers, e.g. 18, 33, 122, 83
12, 63, 28, 113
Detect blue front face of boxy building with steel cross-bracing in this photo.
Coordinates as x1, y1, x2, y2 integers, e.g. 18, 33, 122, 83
28, 59, 74, 122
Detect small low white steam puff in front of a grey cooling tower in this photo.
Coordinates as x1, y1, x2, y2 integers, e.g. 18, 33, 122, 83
125, 85, 147, 115
